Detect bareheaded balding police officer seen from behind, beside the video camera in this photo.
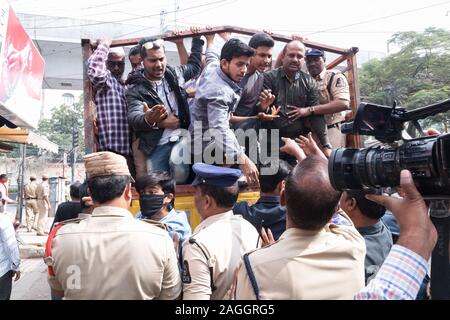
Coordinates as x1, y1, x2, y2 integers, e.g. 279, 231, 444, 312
235, 156, 365, 300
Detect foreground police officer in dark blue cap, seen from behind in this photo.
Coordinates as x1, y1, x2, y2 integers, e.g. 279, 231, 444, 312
182, 163, 258, 300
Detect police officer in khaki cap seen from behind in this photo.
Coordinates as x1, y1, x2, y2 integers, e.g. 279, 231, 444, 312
45, 152, 181, 300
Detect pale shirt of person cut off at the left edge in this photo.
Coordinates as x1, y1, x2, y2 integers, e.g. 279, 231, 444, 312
0, 213, 20, 277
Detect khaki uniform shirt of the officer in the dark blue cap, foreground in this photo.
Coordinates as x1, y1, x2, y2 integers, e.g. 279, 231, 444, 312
181, 211, 258, 300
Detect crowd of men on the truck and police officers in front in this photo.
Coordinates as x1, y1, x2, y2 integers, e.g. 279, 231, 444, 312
0, 28, 437, 300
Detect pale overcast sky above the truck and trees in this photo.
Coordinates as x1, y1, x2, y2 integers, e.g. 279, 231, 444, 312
9, 0, 450, 53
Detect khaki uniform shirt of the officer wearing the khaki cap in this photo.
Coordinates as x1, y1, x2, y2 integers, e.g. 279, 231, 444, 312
48, 207, 181, 300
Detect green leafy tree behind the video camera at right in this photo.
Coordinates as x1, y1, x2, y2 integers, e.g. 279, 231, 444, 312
359, 28, 450, 130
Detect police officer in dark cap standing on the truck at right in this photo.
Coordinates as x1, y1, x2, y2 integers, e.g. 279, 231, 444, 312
305, 49, 350, 148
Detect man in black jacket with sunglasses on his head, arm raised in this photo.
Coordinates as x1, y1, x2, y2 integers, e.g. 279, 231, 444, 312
127, 37, 203, 183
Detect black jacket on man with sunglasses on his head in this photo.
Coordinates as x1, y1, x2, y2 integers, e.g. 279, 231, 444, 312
127, 38, 203, 156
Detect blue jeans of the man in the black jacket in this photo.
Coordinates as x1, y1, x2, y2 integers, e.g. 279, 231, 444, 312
147, 138, 191, 184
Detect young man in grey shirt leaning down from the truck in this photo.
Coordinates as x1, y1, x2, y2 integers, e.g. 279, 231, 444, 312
189, 39, 258, 183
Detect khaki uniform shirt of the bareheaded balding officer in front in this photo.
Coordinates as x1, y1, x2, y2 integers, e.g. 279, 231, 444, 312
236, 214, 366, 300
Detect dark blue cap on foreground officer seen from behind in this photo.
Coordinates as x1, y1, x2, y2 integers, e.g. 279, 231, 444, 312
192, 163, 242, 187
